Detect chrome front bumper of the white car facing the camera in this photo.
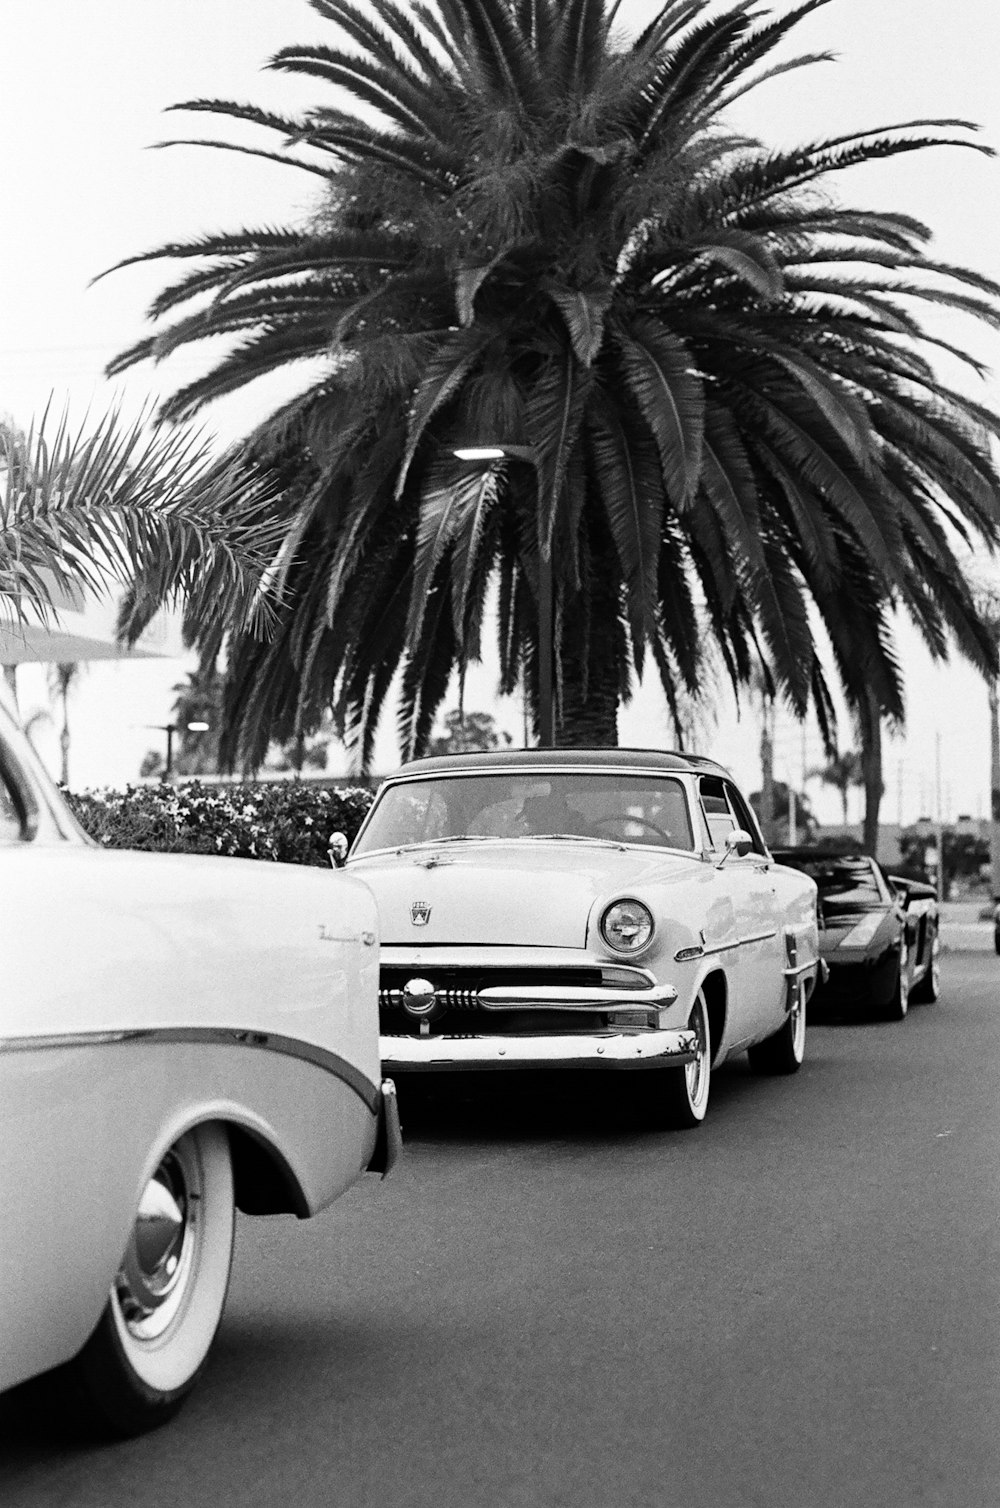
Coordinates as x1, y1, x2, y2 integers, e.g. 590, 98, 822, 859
382, 1027, 698, 1074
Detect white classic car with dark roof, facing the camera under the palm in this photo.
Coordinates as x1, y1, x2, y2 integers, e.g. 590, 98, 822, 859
330, 749, 822, 1126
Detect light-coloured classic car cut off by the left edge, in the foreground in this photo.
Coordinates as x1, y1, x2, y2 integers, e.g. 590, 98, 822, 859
0, 684, 398, 1434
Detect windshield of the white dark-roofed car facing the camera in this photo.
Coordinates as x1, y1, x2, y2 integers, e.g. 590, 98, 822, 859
354, 771, 694, 855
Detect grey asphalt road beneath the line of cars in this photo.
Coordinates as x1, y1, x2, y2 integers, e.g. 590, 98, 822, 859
0, 953, 1000, 1508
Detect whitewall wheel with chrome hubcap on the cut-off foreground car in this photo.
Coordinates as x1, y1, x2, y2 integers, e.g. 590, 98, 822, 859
68, 1125, 235, 1436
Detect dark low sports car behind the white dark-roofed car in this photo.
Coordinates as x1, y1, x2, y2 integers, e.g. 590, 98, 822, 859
775, 847, 941, 1021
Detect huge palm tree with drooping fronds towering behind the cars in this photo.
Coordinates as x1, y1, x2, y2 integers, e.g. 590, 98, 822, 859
103, 0, 1000, 766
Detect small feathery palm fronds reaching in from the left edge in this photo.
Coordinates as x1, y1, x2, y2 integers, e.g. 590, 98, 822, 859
0, 413, 281, 641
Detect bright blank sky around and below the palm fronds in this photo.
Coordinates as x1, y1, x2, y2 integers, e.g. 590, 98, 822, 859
0, 0, 1000, 822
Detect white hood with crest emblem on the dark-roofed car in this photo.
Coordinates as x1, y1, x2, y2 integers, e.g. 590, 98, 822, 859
348, 838, 701, 949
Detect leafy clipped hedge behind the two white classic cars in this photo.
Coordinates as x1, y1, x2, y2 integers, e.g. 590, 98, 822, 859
63, 780, 373, 864
